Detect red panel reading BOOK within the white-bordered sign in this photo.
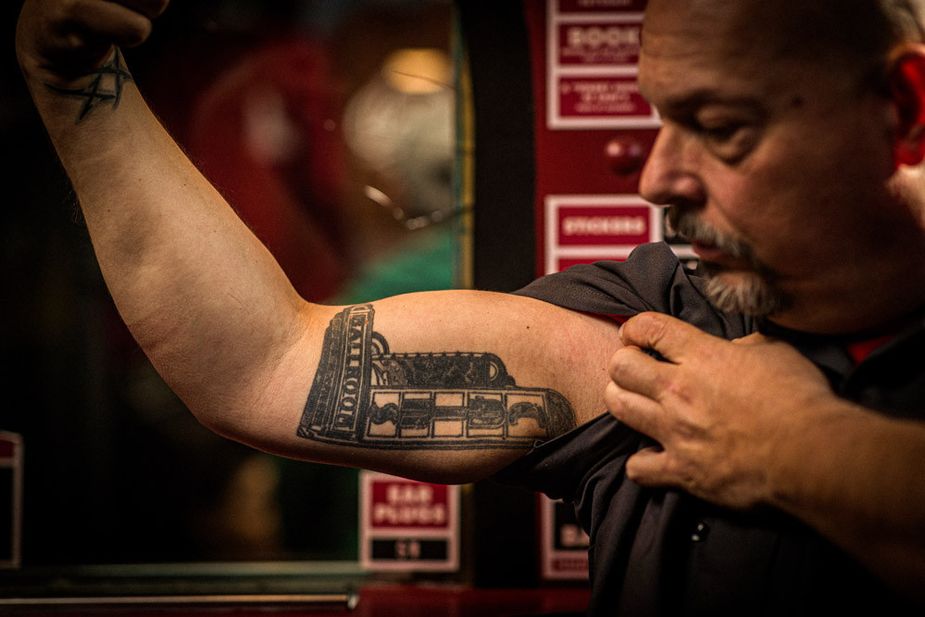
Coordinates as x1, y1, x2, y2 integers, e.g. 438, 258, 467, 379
558, 21, 642, 68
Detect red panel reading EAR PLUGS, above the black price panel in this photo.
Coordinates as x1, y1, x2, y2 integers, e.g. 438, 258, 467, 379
369, 480, 450, 529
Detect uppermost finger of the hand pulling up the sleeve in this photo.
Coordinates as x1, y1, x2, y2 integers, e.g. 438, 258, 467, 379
620, 313, 720, 362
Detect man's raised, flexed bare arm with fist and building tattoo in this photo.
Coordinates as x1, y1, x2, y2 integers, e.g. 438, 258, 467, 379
17, 0, 617, 481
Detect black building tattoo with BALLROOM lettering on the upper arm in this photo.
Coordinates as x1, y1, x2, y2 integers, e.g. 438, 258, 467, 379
297, 304, 575, 450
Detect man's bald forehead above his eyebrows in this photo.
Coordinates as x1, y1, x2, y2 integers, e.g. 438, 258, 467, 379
639, 0, 899, 109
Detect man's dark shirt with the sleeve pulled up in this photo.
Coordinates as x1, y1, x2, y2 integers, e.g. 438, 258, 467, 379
497, 244, 925, 615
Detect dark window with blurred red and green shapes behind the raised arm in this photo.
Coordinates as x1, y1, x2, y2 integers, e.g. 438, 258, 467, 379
0, 0, 465, 566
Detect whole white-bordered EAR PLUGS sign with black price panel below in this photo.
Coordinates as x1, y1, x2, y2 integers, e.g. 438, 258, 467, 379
360, 471, 459, 572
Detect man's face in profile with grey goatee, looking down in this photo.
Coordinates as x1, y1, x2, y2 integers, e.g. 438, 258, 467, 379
639, 0, 897, 327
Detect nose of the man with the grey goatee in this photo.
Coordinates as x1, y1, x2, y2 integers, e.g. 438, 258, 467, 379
639, 125, 706, 206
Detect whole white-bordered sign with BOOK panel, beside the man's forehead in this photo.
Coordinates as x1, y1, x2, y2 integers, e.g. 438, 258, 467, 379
546, 0, 659, 129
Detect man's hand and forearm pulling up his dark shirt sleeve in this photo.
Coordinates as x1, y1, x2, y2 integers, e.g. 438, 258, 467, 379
607, 314, 925, 600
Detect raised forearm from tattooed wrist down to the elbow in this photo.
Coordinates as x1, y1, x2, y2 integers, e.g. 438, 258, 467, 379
21, 49, 301, 424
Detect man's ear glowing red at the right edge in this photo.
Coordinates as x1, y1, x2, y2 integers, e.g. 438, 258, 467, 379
888, 45, 925, 167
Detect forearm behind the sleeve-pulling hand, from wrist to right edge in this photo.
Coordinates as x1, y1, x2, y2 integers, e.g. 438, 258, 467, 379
769, 401, 925, 600
